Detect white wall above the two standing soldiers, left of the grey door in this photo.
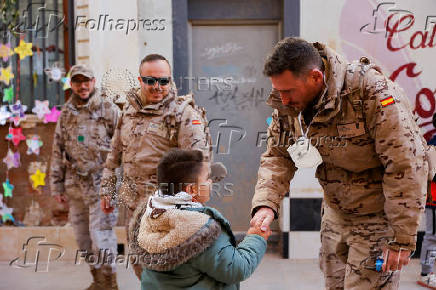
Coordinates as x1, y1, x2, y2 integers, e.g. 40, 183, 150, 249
75, 0, 172, 86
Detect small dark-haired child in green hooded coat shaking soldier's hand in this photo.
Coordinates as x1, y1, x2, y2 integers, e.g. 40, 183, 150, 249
130, 149, 271, 290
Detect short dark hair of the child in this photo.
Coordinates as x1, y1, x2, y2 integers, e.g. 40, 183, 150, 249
157, 149, 203, 195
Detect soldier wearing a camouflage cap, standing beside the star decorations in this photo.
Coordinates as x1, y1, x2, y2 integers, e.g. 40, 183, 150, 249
50, 65, 119, 289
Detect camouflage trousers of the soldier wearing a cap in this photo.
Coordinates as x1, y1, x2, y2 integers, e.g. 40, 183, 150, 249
69, 199, 118, 274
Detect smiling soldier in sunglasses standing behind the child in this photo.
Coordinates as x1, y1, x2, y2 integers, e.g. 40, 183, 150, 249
100, 54, 212, 279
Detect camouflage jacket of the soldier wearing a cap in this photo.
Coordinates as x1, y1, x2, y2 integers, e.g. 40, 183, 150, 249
50, 90, 119, 198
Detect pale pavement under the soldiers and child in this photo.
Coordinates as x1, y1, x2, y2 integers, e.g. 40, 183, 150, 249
0, 253, 426, 290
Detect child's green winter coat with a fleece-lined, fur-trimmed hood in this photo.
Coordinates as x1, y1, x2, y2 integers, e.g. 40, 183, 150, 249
130, 206, 266, 290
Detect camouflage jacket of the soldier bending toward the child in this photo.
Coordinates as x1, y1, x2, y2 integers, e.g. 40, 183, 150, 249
252, 43, 428, 249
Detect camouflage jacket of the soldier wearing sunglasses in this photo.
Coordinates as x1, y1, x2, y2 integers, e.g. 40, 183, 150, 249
100, 89, 212, 209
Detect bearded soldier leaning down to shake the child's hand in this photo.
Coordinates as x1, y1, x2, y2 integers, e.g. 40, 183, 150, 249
251, 38, 428, 289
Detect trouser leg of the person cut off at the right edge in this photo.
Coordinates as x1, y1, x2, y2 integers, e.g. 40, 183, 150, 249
421, 208, 436, 274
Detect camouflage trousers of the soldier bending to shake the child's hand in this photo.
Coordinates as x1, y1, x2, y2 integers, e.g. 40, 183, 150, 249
319, 205, 400, 290
